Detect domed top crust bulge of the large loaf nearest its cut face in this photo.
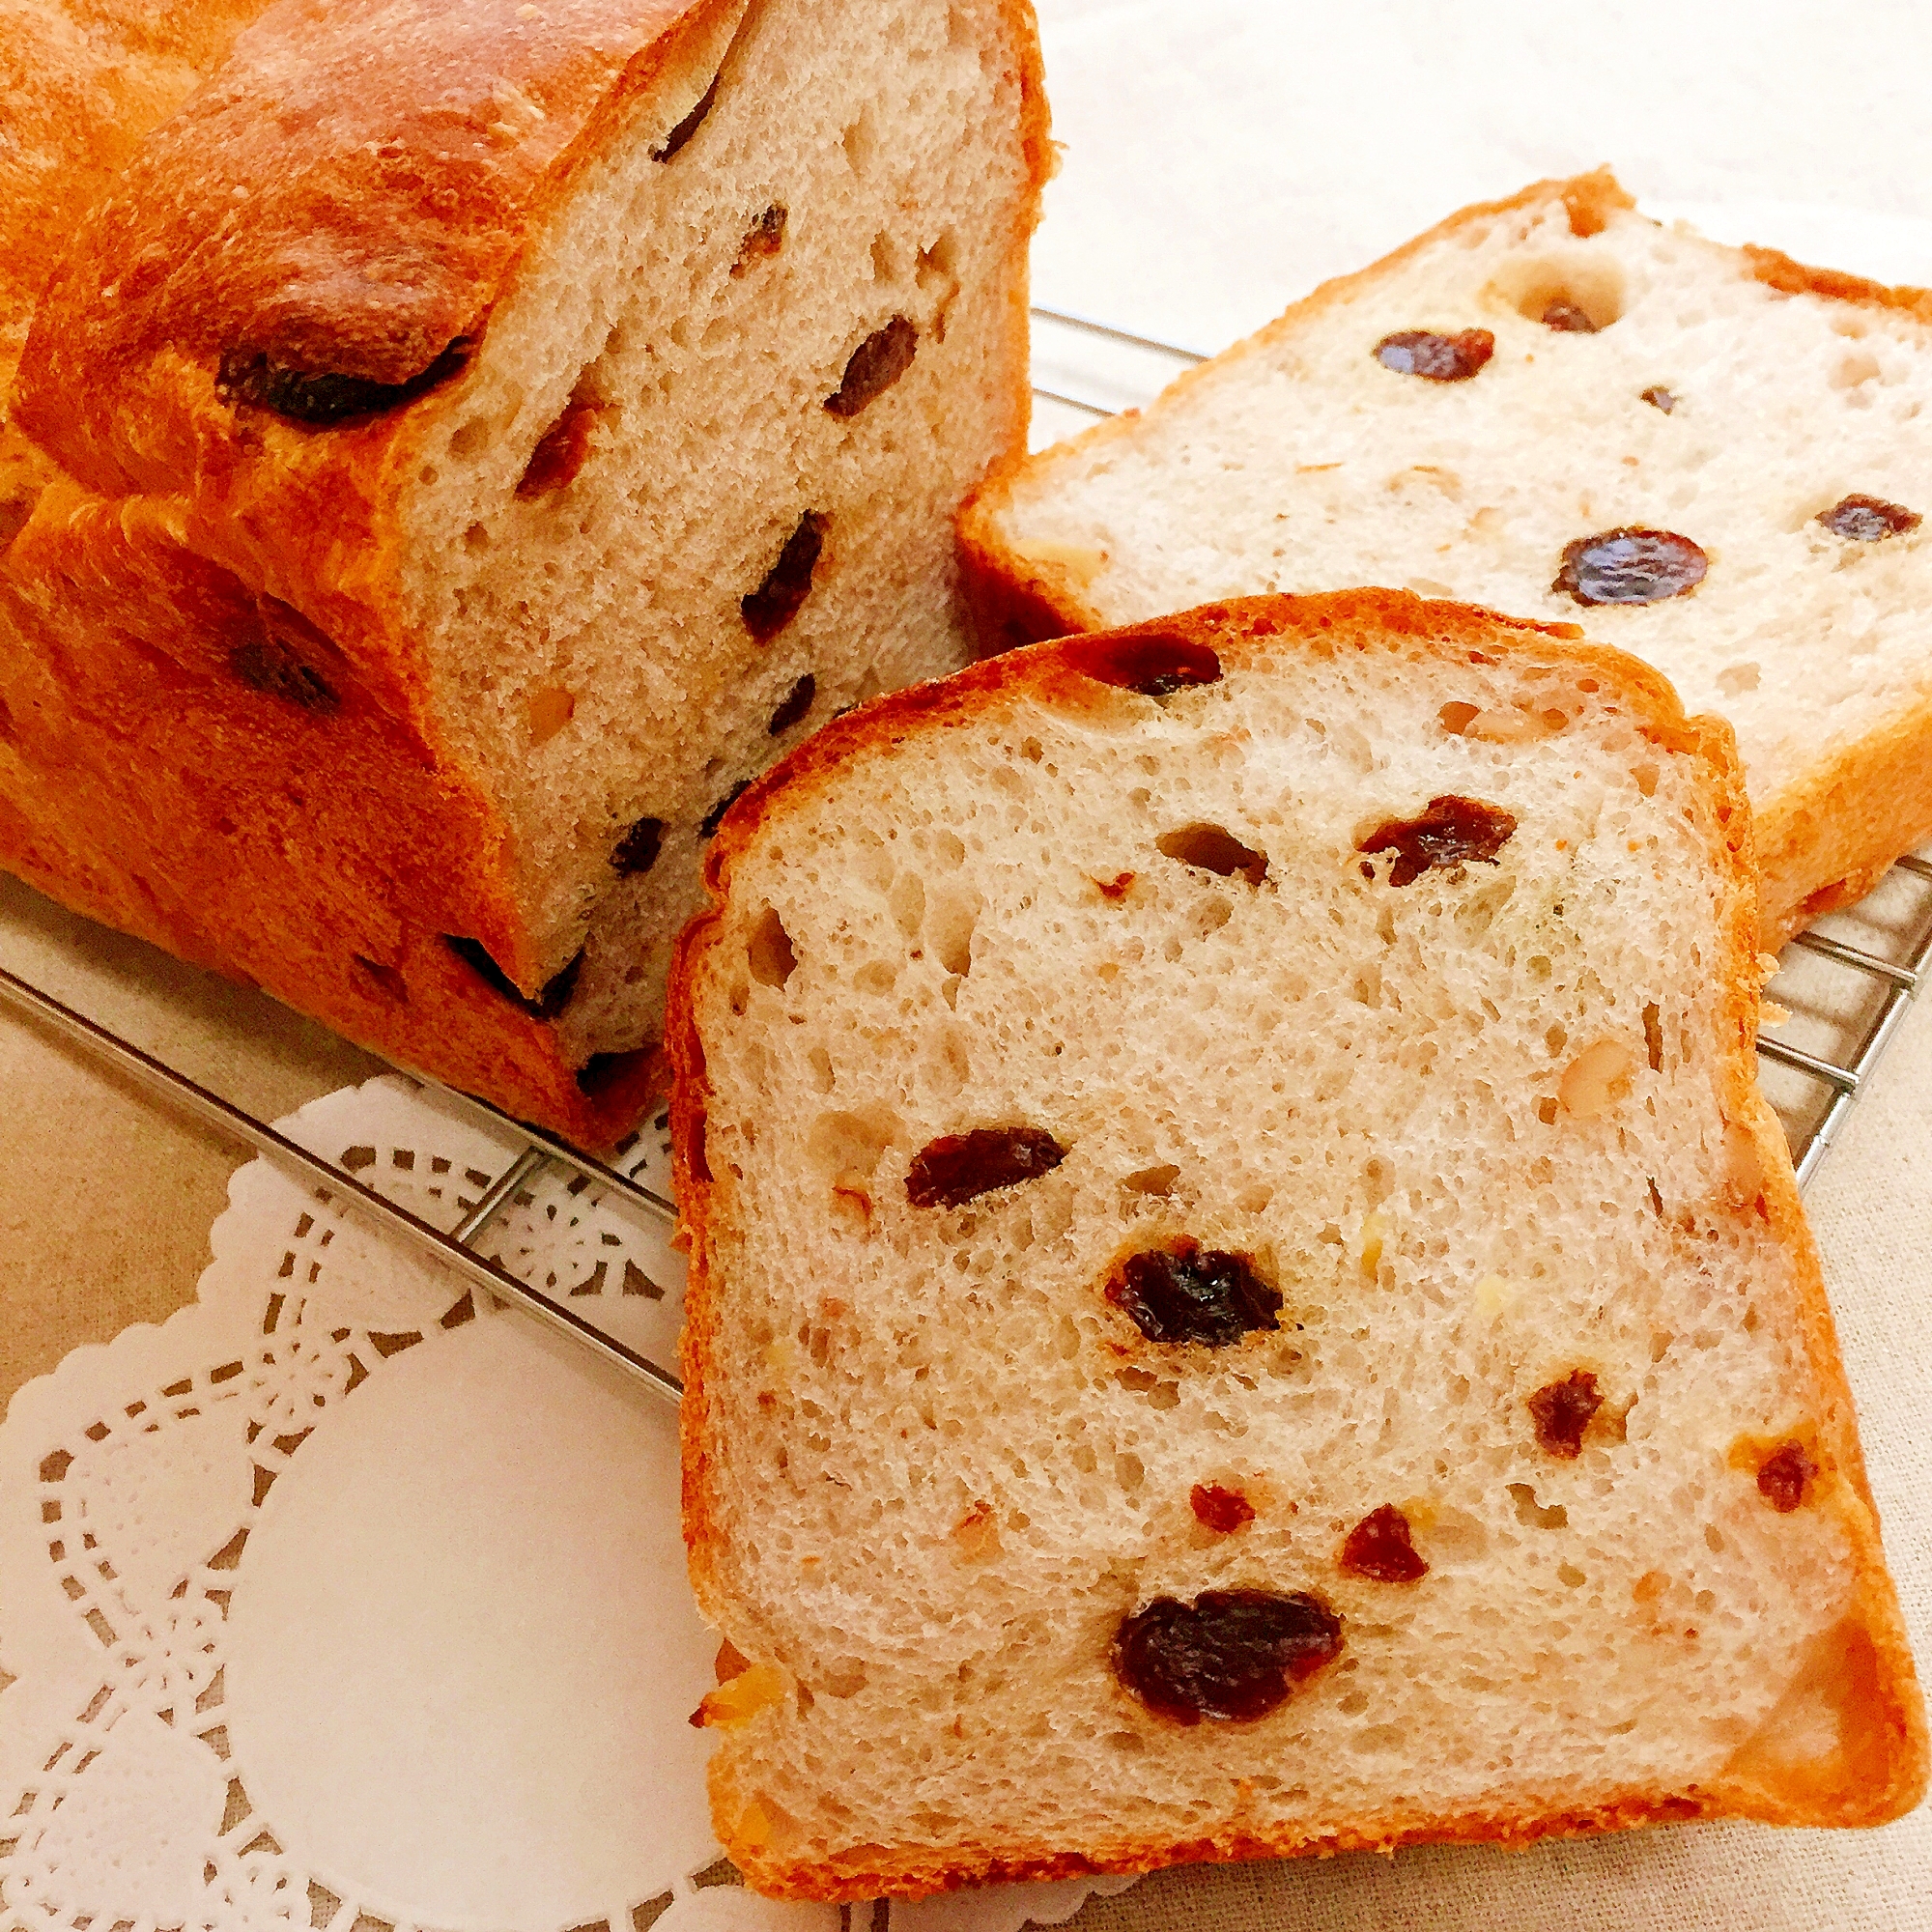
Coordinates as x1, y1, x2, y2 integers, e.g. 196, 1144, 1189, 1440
15, 0, 732, 495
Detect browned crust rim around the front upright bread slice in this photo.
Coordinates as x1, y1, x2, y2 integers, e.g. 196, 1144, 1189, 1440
667, 591, 1926, 1897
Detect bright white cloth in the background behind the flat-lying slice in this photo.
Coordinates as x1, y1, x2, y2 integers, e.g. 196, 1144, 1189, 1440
1034, 0, 1932, 350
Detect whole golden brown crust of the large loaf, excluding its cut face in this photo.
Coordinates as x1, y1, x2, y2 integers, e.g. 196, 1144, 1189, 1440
0, 0, 1051, 1146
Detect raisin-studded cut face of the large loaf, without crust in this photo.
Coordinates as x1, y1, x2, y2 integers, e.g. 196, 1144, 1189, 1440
404, 0, 1026, 1053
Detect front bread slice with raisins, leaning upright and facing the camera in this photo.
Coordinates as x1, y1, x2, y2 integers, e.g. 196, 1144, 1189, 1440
668, 591, 1926, 1897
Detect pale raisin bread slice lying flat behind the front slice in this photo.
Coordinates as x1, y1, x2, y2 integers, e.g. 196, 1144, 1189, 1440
964, 174, 1932, 947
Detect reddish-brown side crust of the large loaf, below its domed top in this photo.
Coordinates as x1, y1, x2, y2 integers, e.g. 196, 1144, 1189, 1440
0, 485, 649, 1146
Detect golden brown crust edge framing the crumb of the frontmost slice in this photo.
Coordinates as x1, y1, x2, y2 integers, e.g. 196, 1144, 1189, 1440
667, 589, 1928, 1901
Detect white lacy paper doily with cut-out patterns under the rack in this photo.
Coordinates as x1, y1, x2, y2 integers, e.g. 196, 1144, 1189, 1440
0, 1078, 1126, 1932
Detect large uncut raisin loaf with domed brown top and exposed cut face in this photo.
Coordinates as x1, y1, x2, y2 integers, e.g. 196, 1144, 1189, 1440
0, 0, 1047, 1142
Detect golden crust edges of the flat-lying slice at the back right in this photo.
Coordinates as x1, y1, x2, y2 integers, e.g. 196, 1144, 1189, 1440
960, 168, 1932, 951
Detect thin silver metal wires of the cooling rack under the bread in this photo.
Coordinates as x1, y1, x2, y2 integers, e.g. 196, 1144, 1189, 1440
0, 298, 1932, 1401
